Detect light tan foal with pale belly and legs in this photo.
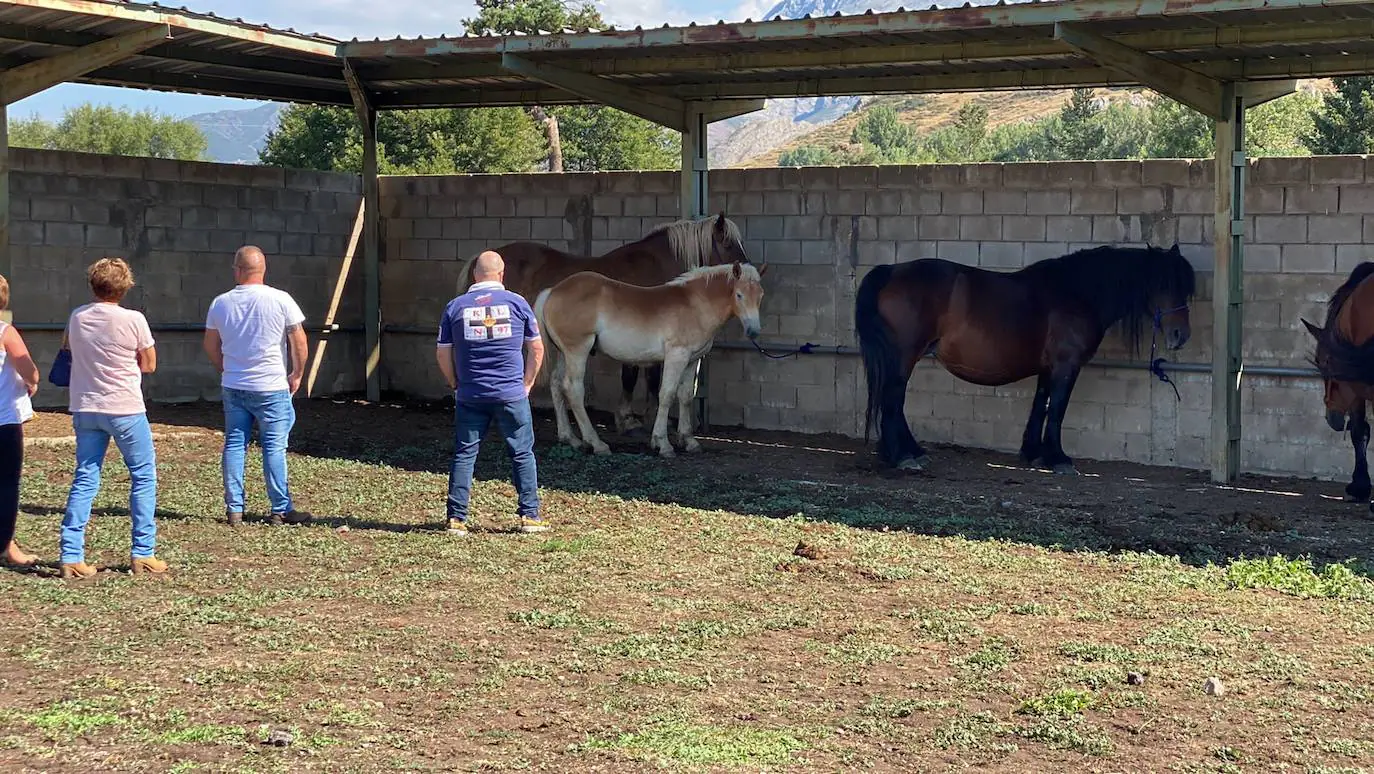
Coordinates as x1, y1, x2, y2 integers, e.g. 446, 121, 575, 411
534, 263, 768, 456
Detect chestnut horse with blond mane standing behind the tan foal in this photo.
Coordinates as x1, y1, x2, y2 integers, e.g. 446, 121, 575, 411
458, 212, 749, 432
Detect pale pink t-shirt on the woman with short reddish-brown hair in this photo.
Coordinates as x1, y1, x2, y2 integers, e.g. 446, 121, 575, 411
67, 302, 153, 417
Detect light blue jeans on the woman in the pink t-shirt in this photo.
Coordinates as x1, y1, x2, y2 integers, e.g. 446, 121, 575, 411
62, 411, 158, 564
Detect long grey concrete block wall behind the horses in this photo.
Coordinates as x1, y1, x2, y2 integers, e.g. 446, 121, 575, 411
382, 157, 1374, 478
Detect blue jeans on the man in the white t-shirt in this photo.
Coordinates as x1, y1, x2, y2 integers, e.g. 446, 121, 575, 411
221, 388, 295, 514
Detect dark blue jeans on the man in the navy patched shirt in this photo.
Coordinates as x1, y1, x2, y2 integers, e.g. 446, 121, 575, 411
448, 400, 539, 521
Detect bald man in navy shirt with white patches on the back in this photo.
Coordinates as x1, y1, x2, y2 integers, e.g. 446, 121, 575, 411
434, 250, 548, 536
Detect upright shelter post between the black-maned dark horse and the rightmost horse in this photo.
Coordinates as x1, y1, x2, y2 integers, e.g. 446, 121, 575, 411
1210, 84, 1246, 484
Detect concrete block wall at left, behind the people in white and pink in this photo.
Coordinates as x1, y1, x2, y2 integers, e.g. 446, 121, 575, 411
8, 148, 363, 406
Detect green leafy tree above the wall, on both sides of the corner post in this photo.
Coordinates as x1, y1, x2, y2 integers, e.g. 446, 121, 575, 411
260, 104, 545, 175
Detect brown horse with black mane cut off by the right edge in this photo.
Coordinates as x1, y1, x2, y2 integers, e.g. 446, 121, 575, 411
1303, 261, 1374, 510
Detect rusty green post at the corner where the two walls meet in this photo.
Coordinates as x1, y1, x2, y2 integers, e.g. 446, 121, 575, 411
344, 59, 382, 403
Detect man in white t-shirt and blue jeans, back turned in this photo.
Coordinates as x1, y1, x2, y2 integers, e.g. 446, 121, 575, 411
205, 245, 311, 527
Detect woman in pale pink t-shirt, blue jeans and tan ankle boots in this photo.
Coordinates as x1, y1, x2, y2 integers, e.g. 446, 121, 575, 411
62, 258, 168, 577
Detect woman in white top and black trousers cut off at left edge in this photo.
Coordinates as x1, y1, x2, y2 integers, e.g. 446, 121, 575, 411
0, 276, 38, 566
